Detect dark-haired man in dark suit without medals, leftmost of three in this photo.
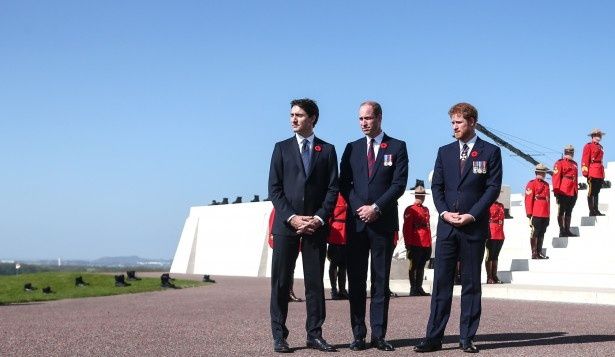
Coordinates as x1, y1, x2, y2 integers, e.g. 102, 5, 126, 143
269, 99, 338, 352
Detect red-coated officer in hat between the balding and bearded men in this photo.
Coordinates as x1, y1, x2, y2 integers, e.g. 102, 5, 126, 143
403, 186, 431, 296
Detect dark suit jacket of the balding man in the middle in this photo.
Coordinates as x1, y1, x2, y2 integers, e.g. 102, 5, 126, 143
340, 134, 408, 233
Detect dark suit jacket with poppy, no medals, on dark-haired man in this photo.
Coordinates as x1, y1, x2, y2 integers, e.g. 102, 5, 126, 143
269, 136, 339, 236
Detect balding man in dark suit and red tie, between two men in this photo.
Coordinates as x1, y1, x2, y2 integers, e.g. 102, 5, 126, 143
340, 101, 408, 351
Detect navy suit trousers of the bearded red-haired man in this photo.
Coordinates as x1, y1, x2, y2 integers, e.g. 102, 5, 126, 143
426, 229, 485, 343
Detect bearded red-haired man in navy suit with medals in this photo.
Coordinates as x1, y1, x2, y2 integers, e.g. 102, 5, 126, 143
414, 103, 502, 353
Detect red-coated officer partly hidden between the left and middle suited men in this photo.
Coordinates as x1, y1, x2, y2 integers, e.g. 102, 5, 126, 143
327, 194, 348, 300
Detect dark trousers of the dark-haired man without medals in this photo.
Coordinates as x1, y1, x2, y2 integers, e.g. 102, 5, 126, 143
270, 234, 327, 340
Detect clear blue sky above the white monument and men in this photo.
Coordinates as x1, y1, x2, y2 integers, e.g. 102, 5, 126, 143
0, 0, 615, 259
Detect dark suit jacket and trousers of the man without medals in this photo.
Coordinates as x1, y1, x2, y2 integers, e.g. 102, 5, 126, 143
269, 136, 338, 341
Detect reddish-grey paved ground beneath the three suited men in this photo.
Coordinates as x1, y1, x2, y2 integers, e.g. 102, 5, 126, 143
0, 277, 615, 356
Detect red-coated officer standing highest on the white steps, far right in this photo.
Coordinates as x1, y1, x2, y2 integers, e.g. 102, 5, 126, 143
581, 129, 606, 216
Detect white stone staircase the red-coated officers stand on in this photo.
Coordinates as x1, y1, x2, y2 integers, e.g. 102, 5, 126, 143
391, 163, 615, 305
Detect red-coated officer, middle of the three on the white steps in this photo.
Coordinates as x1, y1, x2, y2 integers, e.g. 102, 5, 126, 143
553, 145, 579, 237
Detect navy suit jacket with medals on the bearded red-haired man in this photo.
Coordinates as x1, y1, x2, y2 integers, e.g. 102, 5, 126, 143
431, 138, 502, 240
